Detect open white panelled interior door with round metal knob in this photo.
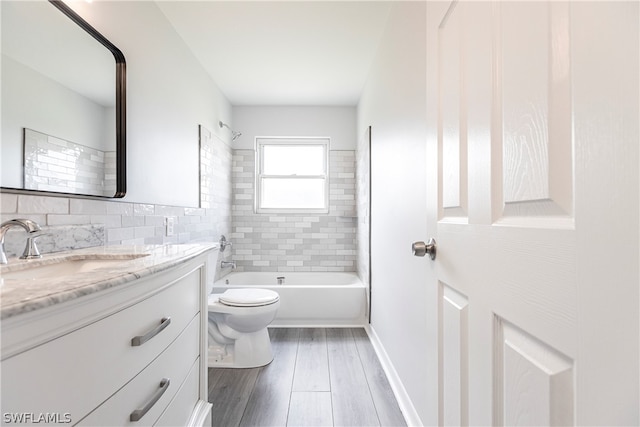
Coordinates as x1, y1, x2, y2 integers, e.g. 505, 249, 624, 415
425, 1, 640, 426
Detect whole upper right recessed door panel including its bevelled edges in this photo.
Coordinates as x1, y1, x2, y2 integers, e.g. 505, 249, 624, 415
493, 2, 573, 226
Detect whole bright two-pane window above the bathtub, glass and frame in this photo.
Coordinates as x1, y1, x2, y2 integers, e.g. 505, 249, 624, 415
256, 138, 329, 213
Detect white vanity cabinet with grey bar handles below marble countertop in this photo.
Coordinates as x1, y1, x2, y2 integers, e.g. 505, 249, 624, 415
0, 249, 211, 426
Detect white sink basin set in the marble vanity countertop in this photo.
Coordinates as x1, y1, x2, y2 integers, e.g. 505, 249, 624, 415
0, 254, 147, 280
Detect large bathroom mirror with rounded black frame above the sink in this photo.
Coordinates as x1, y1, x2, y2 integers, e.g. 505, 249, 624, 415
0, 0, 126, 198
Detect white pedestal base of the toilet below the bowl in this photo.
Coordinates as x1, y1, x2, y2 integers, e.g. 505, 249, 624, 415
207, 328, 273, 368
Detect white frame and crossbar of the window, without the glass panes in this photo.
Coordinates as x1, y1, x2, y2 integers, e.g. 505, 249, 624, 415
255, 137, 331, 214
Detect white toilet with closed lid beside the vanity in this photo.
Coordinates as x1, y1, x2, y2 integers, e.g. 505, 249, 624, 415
208, 288, 280, 368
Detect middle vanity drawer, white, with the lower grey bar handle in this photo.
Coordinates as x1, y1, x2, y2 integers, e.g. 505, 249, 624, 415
78, 315, 200, 426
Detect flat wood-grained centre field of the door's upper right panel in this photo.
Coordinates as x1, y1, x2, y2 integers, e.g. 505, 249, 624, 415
496, 3, 550, 203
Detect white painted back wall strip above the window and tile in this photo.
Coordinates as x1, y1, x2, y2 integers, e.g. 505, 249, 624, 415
232, 107, 357, 150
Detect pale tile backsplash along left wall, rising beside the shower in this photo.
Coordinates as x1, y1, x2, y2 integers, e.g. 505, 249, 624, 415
0, 134, 232, 270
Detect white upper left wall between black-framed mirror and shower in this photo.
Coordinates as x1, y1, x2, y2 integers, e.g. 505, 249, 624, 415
62, 1, 231, 206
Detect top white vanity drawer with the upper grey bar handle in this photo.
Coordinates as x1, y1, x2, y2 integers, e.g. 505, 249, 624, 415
2, 268, 202, 423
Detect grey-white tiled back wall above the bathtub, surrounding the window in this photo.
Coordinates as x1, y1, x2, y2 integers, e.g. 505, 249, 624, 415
231, 150, 357, 271
